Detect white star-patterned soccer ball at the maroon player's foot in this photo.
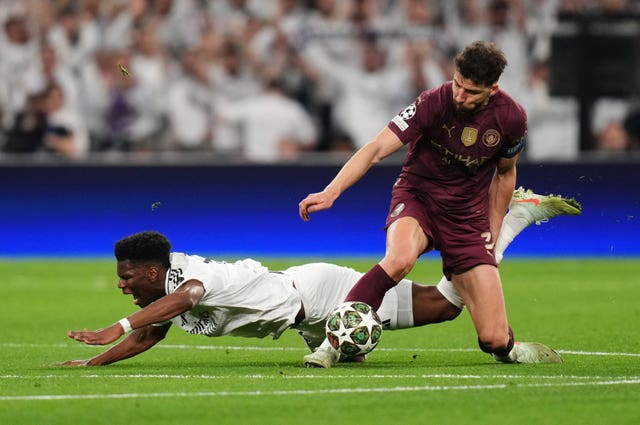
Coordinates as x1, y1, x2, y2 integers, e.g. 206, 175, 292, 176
325, 301, 382, 357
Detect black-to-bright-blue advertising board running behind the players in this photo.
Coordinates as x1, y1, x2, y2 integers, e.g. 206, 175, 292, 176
0, 161, 640, 258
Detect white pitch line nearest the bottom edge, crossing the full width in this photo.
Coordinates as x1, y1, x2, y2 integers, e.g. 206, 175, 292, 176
0, 379, 640, 401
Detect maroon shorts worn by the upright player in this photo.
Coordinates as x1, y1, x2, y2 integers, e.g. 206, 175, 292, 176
385, 186, 498, 279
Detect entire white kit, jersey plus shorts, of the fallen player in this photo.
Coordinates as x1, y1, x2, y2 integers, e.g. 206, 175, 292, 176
165, 252, 422, 349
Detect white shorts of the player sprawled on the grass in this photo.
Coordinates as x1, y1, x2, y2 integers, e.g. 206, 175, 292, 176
283, 263, 413, 350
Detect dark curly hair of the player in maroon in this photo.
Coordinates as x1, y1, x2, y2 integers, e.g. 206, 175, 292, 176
454, 41, 507, 87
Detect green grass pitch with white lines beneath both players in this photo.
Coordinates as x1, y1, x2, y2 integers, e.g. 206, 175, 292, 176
0, 259, 640, 425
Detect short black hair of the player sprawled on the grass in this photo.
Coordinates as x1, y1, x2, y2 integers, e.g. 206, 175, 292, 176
114, 231, 171, 268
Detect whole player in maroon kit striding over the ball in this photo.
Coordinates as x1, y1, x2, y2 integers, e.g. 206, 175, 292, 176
299, 41, 561, 367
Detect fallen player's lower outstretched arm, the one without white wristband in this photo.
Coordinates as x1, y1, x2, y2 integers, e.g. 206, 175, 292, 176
56, 322, 171, 366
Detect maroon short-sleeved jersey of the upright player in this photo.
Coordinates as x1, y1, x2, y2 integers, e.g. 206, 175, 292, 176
388, 82, 527, 218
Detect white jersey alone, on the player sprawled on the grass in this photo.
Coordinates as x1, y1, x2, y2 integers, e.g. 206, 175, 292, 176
165, 252, 302, 339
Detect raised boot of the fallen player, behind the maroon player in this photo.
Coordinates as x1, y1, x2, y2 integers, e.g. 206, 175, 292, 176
509, 187, 582, 224
